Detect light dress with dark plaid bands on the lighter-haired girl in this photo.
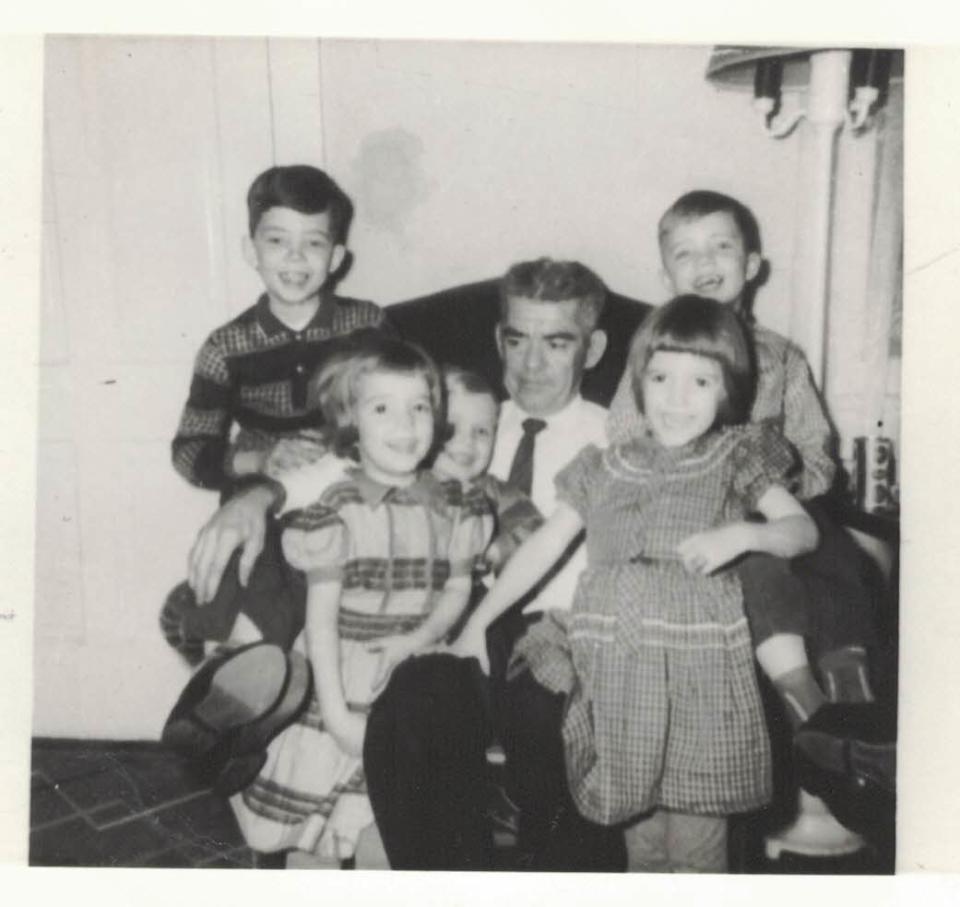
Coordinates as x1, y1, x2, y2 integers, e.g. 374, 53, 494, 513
231, 470, 493, 859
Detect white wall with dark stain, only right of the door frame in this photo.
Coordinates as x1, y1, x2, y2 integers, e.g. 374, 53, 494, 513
321, 41, 797, 329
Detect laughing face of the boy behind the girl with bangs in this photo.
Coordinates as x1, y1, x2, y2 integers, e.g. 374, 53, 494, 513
660, 211, 761, 305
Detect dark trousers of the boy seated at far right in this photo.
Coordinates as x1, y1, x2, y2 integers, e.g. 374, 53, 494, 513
736, 501, 877, 659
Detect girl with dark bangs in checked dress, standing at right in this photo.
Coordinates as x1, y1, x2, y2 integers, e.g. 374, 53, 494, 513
456, 296, 817, 871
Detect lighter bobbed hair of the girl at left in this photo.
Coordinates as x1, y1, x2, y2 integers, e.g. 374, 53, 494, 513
307, 328, 446, 460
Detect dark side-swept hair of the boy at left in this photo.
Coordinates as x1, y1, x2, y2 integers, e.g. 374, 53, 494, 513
247, 164, 353, 245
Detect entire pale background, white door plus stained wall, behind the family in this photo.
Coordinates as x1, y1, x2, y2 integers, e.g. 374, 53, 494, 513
34, 38, 896, 738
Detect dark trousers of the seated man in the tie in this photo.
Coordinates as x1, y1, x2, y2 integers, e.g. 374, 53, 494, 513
363, 623, 626, 871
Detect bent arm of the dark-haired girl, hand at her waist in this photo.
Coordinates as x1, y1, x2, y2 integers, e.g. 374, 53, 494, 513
677, 485, 819, 573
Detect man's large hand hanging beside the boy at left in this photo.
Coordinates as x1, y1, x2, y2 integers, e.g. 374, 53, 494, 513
187, 486, 274, 605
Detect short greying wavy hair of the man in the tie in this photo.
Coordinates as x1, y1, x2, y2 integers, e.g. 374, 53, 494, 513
500, 258, 607, 332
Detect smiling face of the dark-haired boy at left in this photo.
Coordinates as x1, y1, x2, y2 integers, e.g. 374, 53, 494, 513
244, 207, 344, 310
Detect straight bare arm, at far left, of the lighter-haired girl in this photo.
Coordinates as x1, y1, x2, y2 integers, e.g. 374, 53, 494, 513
306, 580, 366, 756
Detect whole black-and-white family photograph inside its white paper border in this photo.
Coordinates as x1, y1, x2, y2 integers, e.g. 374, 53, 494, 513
28, 34, 910, 876
